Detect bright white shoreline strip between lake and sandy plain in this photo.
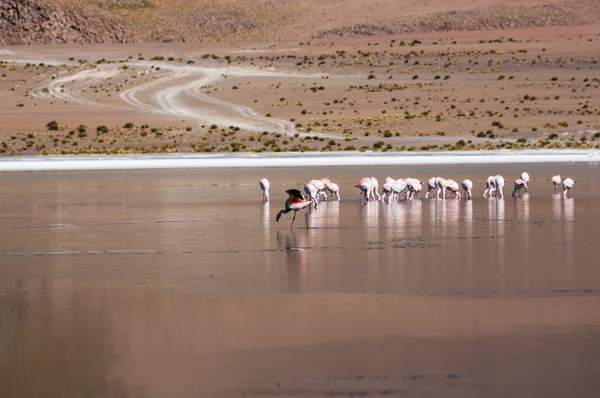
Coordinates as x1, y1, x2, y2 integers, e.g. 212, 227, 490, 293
0, 150, 600, 172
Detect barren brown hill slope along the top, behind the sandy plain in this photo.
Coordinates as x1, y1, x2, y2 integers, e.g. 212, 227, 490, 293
0, 0, 600, 44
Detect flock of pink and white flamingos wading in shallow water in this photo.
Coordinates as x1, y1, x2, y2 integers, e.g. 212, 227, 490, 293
259, 172, 575, 228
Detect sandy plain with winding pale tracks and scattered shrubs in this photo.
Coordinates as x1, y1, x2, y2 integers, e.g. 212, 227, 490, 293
0, 25, 600, 155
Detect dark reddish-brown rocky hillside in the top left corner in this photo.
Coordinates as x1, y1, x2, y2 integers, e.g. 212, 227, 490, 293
0, 0, 135, 45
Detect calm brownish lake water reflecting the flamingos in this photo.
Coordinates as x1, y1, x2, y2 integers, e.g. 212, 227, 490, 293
0, 165, 600, 397
